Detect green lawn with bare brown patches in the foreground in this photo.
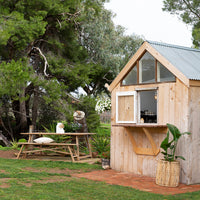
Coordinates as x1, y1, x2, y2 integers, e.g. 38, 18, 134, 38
0, 158, 200, 200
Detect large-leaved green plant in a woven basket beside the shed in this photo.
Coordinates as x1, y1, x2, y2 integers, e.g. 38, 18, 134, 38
156, 124, 191, 187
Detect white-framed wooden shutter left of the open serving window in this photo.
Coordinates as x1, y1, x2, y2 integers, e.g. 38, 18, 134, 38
116, 91, 137, 123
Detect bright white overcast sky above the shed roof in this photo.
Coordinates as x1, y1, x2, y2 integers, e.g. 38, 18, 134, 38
105, 0, 192, 47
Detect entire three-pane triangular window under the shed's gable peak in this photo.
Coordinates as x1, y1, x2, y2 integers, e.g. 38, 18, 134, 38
122, 52, 176, 86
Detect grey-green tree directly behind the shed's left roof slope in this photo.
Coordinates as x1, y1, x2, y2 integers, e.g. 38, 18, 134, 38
80, 8, 143, 96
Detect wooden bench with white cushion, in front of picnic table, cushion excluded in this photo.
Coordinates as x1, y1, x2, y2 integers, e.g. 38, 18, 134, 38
17, 142, 77, 162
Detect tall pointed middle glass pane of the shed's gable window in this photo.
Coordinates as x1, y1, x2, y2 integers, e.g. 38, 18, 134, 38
139, 52, 155, 83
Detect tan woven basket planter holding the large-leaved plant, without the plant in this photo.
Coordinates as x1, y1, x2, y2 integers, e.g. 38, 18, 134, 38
156, 160, 180, 187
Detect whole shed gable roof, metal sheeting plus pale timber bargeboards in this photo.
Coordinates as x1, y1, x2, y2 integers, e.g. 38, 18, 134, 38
109, 41, 200, 91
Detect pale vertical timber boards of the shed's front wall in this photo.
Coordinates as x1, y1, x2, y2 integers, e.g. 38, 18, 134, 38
111, 79, 191, 182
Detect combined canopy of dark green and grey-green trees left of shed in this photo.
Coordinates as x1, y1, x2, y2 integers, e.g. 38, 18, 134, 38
0, 0, 142, 138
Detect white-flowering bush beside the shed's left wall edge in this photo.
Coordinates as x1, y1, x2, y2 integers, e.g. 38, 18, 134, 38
95, 94, 111, 114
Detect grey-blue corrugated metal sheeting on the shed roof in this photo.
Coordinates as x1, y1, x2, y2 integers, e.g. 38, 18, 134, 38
147, 41, 200, 80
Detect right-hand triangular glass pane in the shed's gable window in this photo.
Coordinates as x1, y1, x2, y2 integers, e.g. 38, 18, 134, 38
157, 62, 175, 82
